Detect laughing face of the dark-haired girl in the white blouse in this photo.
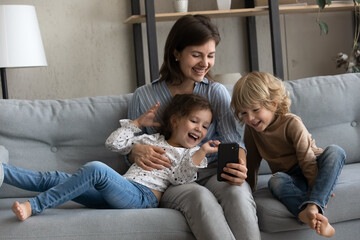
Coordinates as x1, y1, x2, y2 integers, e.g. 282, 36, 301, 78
168, 109, 212, 148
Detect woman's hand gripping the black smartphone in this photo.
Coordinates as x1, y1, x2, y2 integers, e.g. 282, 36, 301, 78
221, 148, 247, 186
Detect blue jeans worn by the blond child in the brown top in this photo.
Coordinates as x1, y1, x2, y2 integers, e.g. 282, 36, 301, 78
268, 145, 346, 217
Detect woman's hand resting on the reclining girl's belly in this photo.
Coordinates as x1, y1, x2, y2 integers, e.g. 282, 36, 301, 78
129, 144, 171, 171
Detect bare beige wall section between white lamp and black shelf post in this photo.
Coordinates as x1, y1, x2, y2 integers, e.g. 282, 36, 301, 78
0, 0, 136, 99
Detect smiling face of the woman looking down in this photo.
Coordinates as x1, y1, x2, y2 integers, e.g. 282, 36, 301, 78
174, 39, 216, 82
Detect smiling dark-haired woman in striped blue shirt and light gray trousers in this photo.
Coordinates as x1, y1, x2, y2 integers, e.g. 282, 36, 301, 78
128, 15, 260, 240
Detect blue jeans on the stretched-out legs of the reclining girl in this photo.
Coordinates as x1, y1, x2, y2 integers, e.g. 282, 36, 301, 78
3, 161, 158, 214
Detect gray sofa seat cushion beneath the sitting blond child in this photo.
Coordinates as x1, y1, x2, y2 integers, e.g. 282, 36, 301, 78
254, 163, 360, 233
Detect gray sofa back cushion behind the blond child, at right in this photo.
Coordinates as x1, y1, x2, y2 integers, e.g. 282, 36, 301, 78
285, 73, 360, 163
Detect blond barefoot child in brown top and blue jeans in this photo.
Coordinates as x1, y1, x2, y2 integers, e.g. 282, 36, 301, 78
231, 72, 345, 237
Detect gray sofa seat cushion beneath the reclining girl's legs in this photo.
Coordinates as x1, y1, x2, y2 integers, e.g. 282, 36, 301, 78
0, 198, 195, 240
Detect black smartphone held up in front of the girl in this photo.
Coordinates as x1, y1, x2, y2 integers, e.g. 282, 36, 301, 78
217, 143, 239, 181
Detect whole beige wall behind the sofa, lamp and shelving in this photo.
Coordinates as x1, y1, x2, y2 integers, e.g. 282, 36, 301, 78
0, 0, 352, 99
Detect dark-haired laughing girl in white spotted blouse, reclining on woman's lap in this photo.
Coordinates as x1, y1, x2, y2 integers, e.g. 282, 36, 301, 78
0, 94, 220, 220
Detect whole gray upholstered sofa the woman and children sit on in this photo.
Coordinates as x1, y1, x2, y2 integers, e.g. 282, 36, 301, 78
0, 74, 360, 240
